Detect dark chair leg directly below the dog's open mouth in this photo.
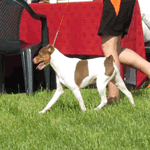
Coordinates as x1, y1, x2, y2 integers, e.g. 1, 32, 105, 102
44, 65, 51, 90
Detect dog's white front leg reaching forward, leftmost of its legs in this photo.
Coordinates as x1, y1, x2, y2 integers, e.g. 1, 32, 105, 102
39, 78, 64, 113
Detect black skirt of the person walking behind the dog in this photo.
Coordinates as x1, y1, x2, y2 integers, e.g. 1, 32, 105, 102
98, 0, 136, 38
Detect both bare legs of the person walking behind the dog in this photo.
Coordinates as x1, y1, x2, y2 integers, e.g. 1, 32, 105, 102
102, 36, 150, 102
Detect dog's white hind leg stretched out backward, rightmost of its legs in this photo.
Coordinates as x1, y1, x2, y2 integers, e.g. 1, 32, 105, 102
113, 72, 135, 106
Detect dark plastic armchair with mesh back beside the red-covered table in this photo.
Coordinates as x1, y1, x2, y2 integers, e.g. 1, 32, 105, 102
0, 0, 50, 95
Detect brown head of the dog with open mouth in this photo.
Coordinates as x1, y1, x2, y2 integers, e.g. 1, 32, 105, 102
33, 45, 55, 70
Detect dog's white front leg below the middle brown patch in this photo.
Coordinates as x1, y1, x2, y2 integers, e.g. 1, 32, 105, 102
72, 88, 86, 111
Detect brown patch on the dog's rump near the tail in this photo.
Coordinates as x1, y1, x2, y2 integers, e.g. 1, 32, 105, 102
104, 55, 114, 76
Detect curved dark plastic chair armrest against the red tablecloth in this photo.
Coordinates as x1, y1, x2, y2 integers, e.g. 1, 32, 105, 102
13, 0, 49, 47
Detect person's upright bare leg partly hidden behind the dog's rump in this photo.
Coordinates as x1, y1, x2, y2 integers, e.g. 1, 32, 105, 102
102, 35, 121, 102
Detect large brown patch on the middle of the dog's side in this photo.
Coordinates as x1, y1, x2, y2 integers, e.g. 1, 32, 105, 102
75, 60, 89, 86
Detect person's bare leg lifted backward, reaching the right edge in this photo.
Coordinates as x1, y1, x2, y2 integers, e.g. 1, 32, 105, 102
118, 48, 150, 79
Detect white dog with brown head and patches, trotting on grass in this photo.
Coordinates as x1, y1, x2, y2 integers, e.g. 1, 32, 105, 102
33, 45, 135, 113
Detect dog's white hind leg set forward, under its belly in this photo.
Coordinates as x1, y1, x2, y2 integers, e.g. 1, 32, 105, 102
94, 76, 109, 110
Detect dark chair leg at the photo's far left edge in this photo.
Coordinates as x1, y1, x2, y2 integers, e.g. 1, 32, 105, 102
0, 55, 5, 94
